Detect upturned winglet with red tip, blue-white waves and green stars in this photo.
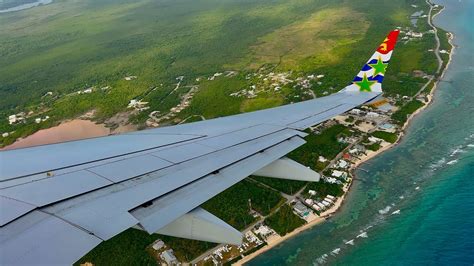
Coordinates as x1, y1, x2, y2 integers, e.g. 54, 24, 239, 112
342, 30, 400, 93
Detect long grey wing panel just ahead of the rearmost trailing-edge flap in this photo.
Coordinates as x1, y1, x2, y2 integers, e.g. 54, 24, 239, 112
45, 129, 300, 241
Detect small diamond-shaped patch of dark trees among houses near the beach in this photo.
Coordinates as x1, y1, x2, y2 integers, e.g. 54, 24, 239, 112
265, 204, 305, 236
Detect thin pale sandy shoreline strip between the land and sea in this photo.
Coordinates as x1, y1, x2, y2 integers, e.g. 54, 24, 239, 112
233, 7, 455, 265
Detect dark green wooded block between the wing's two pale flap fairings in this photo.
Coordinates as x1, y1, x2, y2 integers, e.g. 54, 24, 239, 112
202, 180, 283, 230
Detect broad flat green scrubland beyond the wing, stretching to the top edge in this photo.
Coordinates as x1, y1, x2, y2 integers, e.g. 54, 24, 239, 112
0, 0, 435, 148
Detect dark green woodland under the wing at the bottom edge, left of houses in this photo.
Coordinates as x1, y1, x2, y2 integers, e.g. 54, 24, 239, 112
75, 228, 159, 265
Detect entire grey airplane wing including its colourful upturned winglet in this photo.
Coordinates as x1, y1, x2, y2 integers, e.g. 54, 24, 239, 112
0, 31, 398, 265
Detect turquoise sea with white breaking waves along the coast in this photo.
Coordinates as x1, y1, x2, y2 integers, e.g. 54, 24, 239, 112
249, 0, 474, 265
